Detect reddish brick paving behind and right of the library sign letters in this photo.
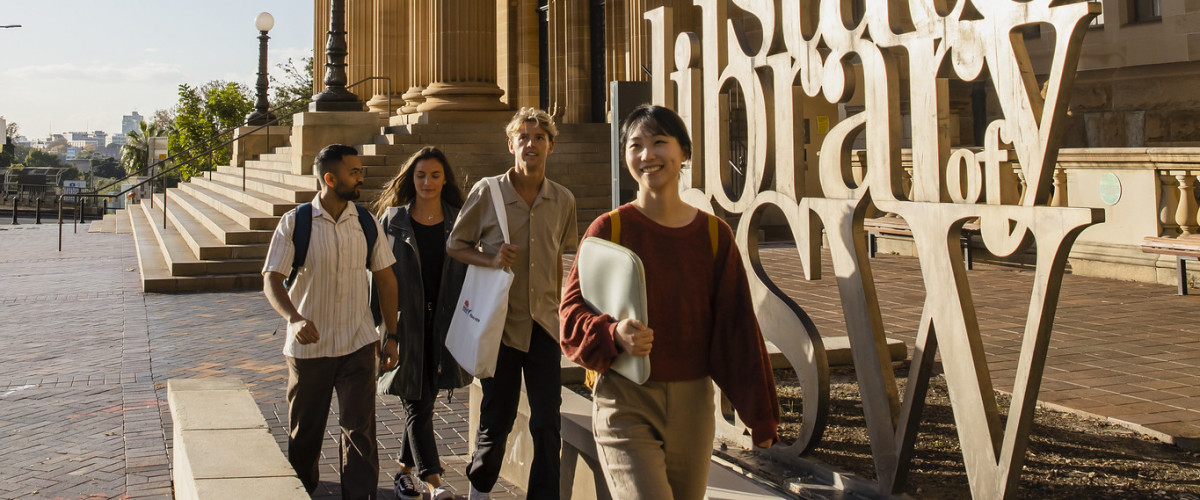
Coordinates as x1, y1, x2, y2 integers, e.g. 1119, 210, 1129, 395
761, 246, 1200, 448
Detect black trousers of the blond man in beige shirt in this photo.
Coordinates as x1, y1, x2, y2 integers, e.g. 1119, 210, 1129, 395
467, 323, 563, 500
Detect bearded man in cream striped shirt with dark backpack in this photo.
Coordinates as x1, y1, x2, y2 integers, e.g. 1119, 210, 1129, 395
263, 144, 398, 499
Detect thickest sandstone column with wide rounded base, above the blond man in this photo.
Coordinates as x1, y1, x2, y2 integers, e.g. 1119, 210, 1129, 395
416, 0, 508, 113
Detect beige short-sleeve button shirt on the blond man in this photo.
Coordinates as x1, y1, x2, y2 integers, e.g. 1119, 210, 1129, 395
446, 173, 578, 351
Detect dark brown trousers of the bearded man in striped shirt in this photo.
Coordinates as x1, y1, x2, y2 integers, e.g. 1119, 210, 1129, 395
287, 343, 379, 500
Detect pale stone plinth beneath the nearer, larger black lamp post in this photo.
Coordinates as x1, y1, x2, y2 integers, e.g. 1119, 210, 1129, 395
285, 112, 380, 175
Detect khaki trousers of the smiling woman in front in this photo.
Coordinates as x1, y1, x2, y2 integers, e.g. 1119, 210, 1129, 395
592, 372, 716, 500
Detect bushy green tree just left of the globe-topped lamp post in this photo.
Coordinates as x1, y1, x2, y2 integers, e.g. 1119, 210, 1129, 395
169, 80, 254, 181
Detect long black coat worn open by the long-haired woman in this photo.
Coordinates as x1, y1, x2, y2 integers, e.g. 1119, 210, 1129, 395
371, 201, 472, 399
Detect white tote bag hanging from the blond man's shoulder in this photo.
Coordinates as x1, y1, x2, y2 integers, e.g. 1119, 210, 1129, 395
446, 177, 512, 379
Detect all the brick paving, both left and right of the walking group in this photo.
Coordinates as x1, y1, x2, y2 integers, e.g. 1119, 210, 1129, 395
7, 224, 1200, 499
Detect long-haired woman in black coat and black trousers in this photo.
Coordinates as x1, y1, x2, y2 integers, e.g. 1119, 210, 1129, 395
371, 147, 470, 500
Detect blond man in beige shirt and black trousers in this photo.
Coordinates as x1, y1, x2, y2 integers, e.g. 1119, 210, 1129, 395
446, 108, 578, 499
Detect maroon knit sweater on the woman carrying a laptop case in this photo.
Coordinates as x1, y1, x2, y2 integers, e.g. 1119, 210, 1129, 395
558, 204, 779, 442
